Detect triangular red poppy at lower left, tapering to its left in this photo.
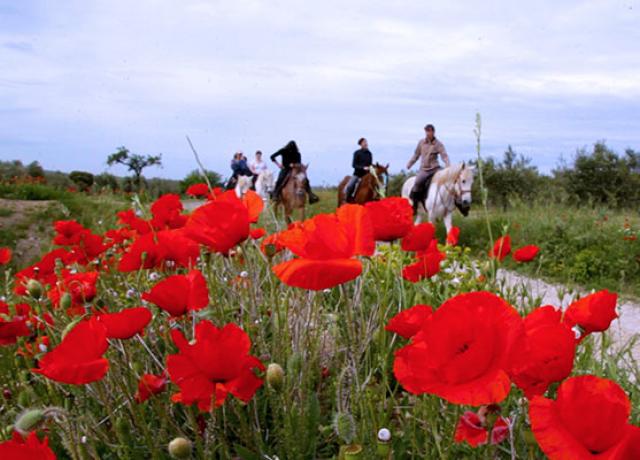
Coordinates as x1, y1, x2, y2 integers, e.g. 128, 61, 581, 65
32, 319, 109, 385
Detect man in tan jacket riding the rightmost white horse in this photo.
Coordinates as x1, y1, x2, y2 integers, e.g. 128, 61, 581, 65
407, 124, 449, 215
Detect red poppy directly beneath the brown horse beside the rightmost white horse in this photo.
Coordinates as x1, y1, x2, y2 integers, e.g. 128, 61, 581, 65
365, 197, 413, 241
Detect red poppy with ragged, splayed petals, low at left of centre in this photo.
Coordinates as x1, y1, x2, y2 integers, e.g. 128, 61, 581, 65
167, 320, 265, 412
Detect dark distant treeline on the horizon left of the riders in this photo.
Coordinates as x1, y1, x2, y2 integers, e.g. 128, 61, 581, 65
0, 160, 222, 197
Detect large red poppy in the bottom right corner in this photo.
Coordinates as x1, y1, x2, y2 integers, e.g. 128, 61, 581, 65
529, 375, 639, 460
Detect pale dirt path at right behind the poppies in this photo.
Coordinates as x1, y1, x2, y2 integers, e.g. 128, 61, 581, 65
498, 269, 640, 360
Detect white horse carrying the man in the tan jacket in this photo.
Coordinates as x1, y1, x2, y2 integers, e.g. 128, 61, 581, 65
402, 163, 475, 233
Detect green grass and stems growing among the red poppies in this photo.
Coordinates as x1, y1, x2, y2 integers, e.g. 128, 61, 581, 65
0, 185, 640, 460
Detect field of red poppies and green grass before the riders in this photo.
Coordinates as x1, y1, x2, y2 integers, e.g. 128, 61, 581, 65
0, 185, 640, 460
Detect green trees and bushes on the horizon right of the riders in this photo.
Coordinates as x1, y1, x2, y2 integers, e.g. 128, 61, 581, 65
389, 142, 640, 209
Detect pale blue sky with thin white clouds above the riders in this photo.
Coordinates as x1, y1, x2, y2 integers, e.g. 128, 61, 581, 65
0, 0, 640, 184
